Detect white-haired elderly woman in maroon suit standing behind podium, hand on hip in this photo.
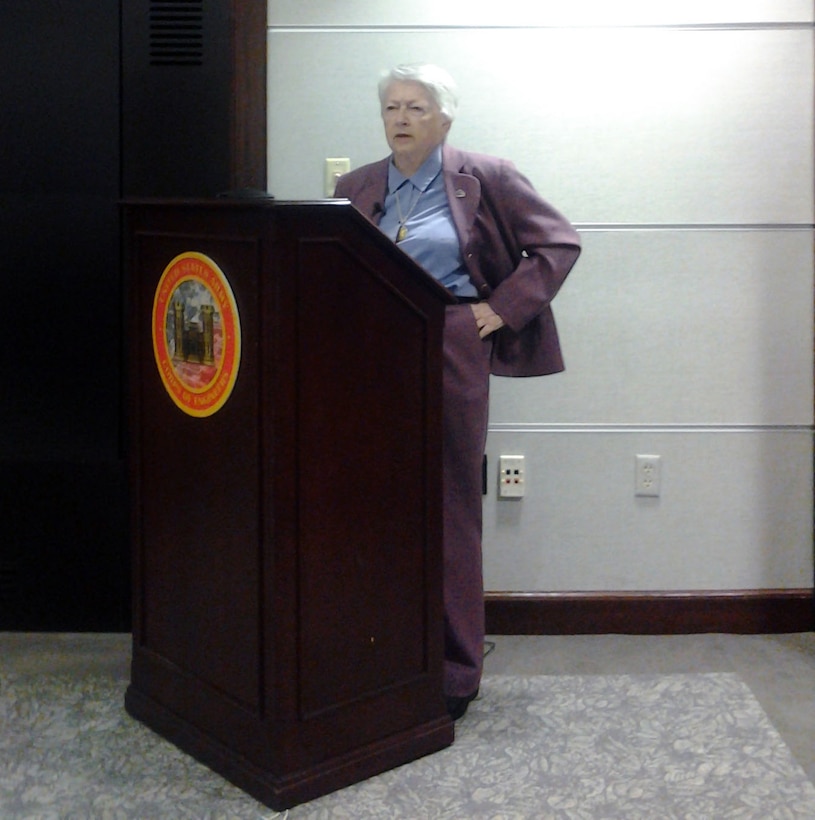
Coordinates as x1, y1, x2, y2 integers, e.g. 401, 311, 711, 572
335, 65, 580, 720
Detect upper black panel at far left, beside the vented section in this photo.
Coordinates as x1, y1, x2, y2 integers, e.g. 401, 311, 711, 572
0, 0, 121, 460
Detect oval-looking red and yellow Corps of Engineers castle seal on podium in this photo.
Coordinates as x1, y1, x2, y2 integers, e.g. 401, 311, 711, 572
153, 251, 241, 417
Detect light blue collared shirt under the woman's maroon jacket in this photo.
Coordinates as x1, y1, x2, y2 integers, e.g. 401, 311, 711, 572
379, 145, 477, 296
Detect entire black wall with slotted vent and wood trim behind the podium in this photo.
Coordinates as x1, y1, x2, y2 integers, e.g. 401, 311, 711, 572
0, 0, 266, 630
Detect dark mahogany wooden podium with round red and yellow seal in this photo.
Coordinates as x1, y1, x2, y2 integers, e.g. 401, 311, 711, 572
124, 199, 454, 810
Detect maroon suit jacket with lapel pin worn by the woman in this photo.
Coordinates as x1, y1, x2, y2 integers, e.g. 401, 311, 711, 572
335, 144, 580, 376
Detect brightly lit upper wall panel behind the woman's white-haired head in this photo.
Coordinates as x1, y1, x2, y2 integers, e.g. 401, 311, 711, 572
268, 28, 813, 225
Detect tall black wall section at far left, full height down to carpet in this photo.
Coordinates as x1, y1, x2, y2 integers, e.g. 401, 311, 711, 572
0, 0, 129, 630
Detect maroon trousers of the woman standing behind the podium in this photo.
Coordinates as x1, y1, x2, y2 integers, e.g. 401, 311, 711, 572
443, 304, 492, 697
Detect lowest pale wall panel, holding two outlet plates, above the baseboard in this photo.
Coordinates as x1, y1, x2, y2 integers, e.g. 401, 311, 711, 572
484, 428, 812, 591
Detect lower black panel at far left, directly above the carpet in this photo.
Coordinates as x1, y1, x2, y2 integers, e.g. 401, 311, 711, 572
0, 461, 130, 632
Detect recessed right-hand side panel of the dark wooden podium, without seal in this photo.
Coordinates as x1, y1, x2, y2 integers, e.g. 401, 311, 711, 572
296, 237, 435, 714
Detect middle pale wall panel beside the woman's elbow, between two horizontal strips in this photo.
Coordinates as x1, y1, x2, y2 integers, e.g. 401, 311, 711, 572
491, 227, 813, 425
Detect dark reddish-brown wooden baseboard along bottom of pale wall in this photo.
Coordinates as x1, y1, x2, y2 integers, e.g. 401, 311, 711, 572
485, 589, 815, 635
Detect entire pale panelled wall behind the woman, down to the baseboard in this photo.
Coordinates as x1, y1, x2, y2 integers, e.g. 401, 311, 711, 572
269, 0, 815, 591
